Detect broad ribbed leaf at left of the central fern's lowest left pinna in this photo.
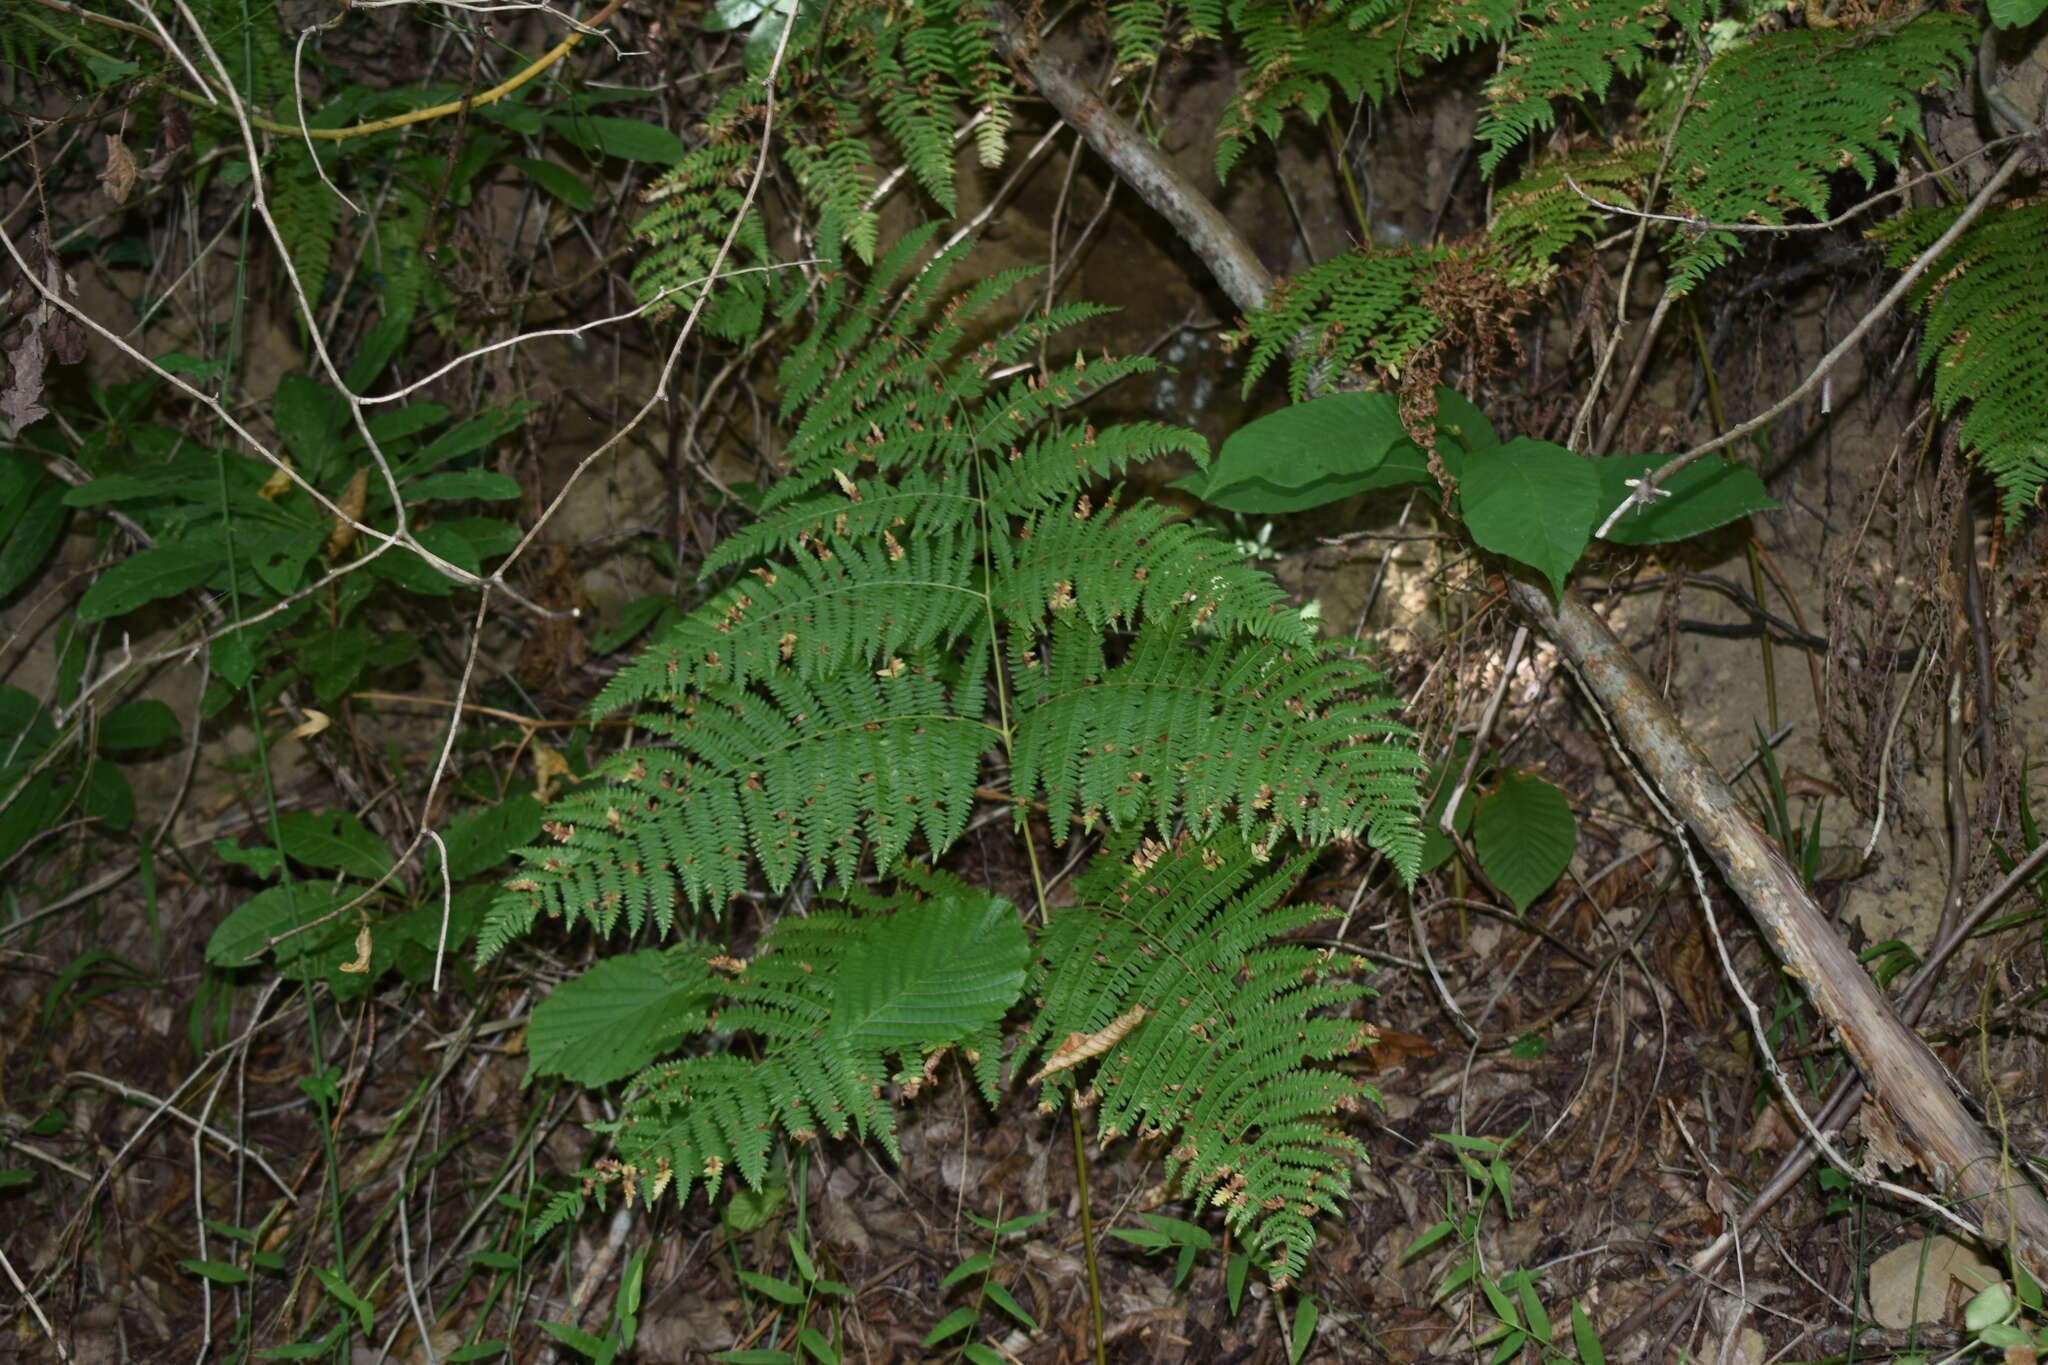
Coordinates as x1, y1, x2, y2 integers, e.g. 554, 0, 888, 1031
526, 950, 711, 1085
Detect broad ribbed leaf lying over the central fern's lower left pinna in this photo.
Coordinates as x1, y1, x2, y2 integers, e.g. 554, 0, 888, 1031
827, 896, 1030, 1048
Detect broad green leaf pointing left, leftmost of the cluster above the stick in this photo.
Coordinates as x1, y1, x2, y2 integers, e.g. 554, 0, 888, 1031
1174, 393, 1421, 516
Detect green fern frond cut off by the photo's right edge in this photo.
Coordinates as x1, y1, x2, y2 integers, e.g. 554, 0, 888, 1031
1872, 203, 2048, 528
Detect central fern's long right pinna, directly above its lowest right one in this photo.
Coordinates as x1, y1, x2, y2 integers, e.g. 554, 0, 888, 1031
1010, 620, 1421, 863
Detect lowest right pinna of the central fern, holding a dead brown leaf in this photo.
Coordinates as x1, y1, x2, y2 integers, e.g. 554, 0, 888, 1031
1018, 833, 1376, 1283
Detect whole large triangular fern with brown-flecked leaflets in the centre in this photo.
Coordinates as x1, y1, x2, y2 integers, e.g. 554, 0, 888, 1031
491, 231, 1421, 1275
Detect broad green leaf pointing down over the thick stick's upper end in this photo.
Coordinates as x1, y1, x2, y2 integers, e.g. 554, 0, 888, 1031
1458, 436, 1602, 593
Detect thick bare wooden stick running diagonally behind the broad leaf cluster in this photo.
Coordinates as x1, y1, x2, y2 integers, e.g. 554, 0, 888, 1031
991, 4, 2048, 1279
